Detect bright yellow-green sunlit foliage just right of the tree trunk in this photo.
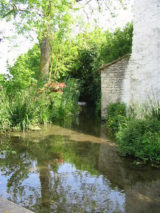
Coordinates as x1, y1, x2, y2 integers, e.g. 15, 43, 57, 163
50, 29, 105, 81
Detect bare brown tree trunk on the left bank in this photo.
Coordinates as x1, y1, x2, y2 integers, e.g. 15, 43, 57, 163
39, 37, 50, 81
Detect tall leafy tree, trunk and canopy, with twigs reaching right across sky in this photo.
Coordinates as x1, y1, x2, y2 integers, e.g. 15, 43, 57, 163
0, 0, 132, 81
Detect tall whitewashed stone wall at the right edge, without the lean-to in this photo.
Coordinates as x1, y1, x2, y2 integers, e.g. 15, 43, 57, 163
126, 0, 160, 105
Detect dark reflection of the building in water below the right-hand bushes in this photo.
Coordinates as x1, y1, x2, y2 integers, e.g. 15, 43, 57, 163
98, 144, 160, 213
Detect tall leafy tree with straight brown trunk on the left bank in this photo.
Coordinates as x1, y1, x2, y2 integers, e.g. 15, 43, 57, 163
0, 0, 74, 80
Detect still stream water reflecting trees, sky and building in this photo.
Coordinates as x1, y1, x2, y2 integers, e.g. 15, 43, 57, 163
0, 110, 160, 213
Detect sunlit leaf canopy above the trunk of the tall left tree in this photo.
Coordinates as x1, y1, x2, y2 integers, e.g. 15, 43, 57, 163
0, 0, 75, 37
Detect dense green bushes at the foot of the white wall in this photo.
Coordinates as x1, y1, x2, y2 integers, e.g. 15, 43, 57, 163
107, 103, 160, 163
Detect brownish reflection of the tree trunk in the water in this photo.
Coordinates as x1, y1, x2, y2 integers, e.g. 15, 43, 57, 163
35, 137, 63, 213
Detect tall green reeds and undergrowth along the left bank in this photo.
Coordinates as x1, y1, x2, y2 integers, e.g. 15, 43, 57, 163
0, 79, 79, 131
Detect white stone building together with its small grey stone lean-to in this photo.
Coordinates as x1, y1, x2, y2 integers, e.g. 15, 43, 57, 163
101, 0, 160, 118
